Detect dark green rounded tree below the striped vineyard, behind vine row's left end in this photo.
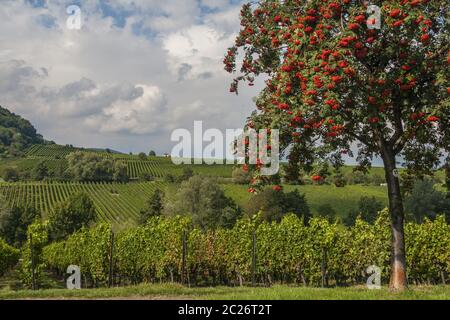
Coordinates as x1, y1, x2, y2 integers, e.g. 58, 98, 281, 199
49, 193, 96, 240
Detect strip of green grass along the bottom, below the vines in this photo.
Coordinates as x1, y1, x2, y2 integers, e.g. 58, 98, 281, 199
0, 284, 450, 300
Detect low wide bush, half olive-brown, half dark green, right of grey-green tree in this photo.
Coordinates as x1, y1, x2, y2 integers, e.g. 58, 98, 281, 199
244, 187, 311, 222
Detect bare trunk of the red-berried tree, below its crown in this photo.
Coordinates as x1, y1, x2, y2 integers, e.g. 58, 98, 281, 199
383, 150, 407, 291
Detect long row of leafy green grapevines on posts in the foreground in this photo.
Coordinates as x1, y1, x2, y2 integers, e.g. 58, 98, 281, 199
22, 210, 450, 287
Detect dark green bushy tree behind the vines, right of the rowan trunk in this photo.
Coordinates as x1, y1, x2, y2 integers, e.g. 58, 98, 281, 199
405, 179, 450, 223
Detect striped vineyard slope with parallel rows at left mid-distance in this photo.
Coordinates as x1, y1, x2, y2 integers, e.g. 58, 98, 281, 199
0, 182, 166, 227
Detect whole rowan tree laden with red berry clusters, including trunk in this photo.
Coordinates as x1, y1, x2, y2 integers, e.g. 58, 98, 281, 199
224, 0, 450, 290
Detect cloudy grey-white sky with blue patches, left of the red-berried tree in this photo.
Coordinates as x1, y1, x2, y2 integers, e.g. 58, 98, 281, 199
0, 0, 261, 153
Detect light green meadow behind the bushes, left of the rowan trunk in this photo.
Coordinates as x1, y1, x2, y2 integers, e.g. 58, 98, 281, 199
224, 184, 388, 217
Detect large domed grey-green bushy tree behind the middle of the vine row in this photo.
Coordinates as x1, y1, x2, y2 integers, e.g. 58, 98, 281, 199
164, 175, 241, 229
